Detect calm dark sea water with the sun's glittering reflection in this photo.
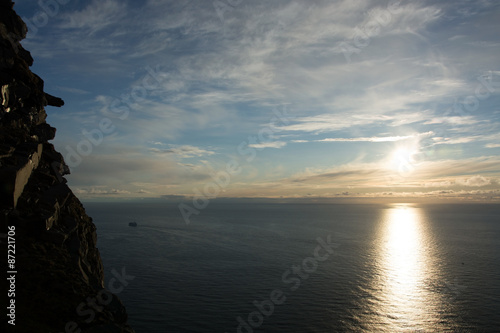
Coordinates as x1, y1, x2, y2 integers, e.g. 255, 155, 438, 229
85, 203, 500, 333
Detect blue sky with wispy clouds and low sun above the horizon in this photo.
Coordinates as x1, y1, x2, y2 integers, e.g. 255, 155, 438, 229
10, 0, 500, 202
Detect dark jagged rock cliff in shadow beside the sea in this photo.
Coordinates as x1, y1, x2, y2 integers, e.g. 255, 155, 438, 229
0, 0, 134, 333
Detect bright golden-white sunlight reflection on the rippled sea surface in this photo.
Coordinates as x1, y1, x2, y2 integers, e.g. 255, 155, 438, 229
372, 204, 448, 332
